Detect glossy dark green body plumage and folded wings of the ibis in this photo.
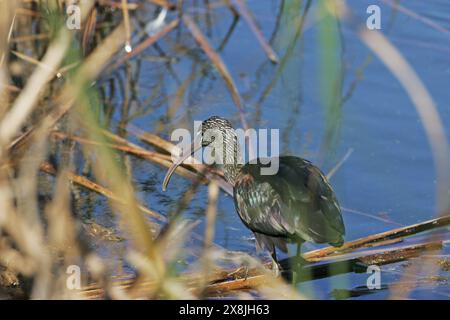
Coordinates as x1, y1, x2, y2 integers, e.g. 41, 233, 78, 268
233, 156, 345, 252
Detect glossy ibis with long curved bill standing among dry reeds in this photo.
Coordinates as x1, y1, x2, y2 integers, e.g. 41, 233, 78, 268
163, 116, 345, 273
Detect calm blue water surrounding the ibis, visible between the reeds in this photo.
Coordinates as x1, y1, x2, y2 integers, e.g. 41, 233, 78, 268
96, 0, 450, 299
